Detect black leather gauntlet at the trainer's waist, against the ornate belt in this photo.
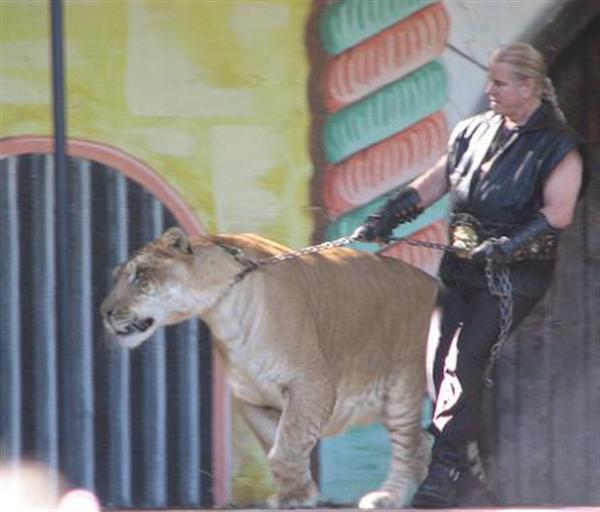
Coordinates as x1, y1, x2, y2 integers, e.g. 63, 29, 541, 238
469, 212, 559, 264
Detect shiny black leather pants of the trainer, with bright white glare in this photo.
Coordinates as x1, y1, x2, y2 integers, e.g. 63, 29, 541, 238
430, 284, 540, 447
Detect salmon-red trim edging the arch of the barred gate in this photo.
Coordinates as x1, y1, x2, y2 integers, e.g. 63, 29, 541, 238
0, 135, 231, 506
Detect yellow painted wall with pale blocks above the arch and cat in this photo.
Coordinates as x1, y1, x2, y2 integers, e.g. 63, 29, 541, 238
0, 0, 312, 247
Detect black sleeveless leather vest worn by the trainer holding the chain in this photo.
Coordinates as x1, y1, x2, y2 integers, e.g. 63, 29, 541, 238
440, 102, 581, 296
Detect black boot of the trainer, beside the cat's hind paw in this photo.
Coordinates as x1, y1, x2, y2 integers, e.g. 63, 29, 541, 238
412, 439, 466, 508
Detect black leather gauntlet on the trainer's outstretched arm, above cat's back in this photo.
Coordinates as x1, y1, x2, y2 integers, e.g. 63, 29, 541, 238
352, 187, 423, 242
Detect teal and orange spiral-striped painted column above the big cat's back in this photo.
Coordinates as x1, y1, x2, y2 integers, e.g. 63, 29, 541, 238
319, 0, 449, 274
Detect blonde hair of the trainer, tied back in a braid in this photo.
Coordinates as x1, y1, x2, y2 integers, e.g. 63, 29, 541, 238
491, 43, 566, 122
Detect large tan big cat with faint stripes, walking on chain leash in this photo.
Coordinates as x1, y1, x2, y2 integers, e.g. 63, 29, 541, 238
102, 228, 436, 508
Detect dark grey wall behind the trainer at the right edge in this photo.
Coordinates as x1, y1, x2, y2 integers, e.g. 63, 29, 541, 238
486, 14, 600, 506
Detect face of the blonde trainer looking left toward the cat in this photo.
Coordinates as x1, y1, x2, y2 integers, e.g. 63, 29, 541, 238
485, 62, 532, 117
